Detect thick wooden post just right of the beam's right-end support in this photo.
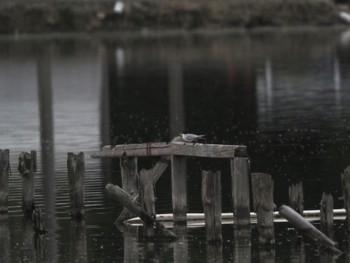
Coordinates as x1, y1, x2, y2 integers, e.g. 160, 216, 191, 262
252, 173, 275, 245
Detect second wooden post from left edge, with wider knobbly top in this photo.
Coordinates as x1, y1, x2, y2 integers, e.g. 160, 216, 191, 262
18, 151, 37, 217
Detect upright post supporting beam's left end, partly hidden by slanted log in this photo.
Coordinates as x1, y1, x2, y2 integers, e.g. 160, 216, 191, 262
120, 152, 138, 220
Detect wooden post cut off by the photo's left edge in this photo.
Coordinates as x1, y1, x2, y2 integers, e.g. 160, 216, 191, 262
0, 149, 10, 214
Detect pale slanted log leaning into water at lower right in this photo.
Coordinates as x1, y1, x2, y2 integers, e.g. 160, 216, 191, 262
279, 205, 341, 253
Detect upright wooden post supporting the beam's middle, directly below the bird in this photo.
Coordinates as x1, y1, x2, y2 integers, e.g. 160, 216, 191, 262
171, 155, 187, 224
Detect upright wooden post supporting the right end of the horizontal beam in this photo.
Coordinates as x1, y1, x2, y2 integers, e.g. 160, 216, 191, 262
231, 157, 250, 226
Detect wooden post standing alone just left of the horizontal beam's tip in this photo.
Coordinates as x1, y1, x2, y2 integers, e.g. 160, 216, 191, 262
67, 152, 85, 220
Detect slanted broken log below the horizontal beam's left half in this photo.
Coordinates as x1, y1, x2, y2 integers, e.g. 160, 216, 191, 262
106, 184, 177, 238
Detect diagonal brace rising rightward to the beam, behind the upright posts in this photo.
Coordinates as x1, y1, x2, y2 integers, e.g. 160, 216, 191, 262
116, 156, 170, 223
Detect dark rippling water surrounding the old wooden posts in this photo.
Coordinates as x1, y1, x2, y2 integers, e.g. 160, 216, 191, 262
0, 29, 350, 262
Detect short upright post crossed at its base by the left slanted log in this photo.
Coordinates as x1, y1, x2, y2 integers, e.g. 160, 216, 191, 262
139, 169, 156, 238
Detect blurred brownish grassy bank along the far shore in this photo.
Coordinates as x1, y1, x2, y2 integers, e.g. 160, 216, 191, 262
0, 0, 344, 34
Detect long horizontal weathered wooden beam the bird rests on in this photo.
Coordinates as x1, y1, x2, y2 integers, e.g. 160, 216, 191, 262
91, 142, 247, 158
